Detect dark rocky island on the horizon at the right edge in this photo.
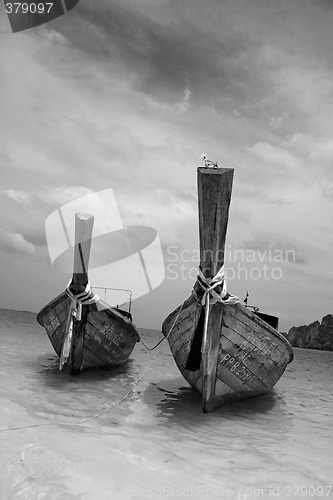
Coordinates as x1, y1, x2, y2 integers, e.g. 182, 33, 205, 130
282, 314, 333, 351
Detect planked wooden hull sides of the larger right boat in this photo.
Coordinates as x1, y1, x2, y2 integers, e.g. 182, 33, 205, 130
162, 294, 293, 409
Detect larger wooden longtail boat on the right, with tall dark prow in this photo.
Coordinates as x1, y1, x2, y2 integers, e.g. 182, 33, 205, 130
162, 161, 293, 412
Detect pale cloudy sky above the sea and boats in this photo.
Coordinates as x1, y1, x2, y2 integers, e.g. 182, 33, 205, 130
0, 0, 333, 330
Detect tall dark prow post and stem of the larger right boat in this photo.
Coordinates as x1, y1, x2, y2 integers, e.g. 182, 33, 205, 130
197, 167, 234, 413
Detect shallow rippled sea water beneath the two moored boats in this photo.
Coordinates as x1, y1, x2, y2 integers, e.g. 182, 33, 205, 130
0, 310, 333, 500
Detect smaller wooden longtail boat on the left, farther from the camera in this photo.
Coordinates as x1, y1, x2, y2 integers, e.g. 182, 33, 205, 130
37, 213, 140, 375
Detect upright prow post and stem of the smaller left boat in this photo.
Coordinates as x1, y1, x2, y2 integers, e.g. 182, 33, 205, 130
59, 212, 94, 374
